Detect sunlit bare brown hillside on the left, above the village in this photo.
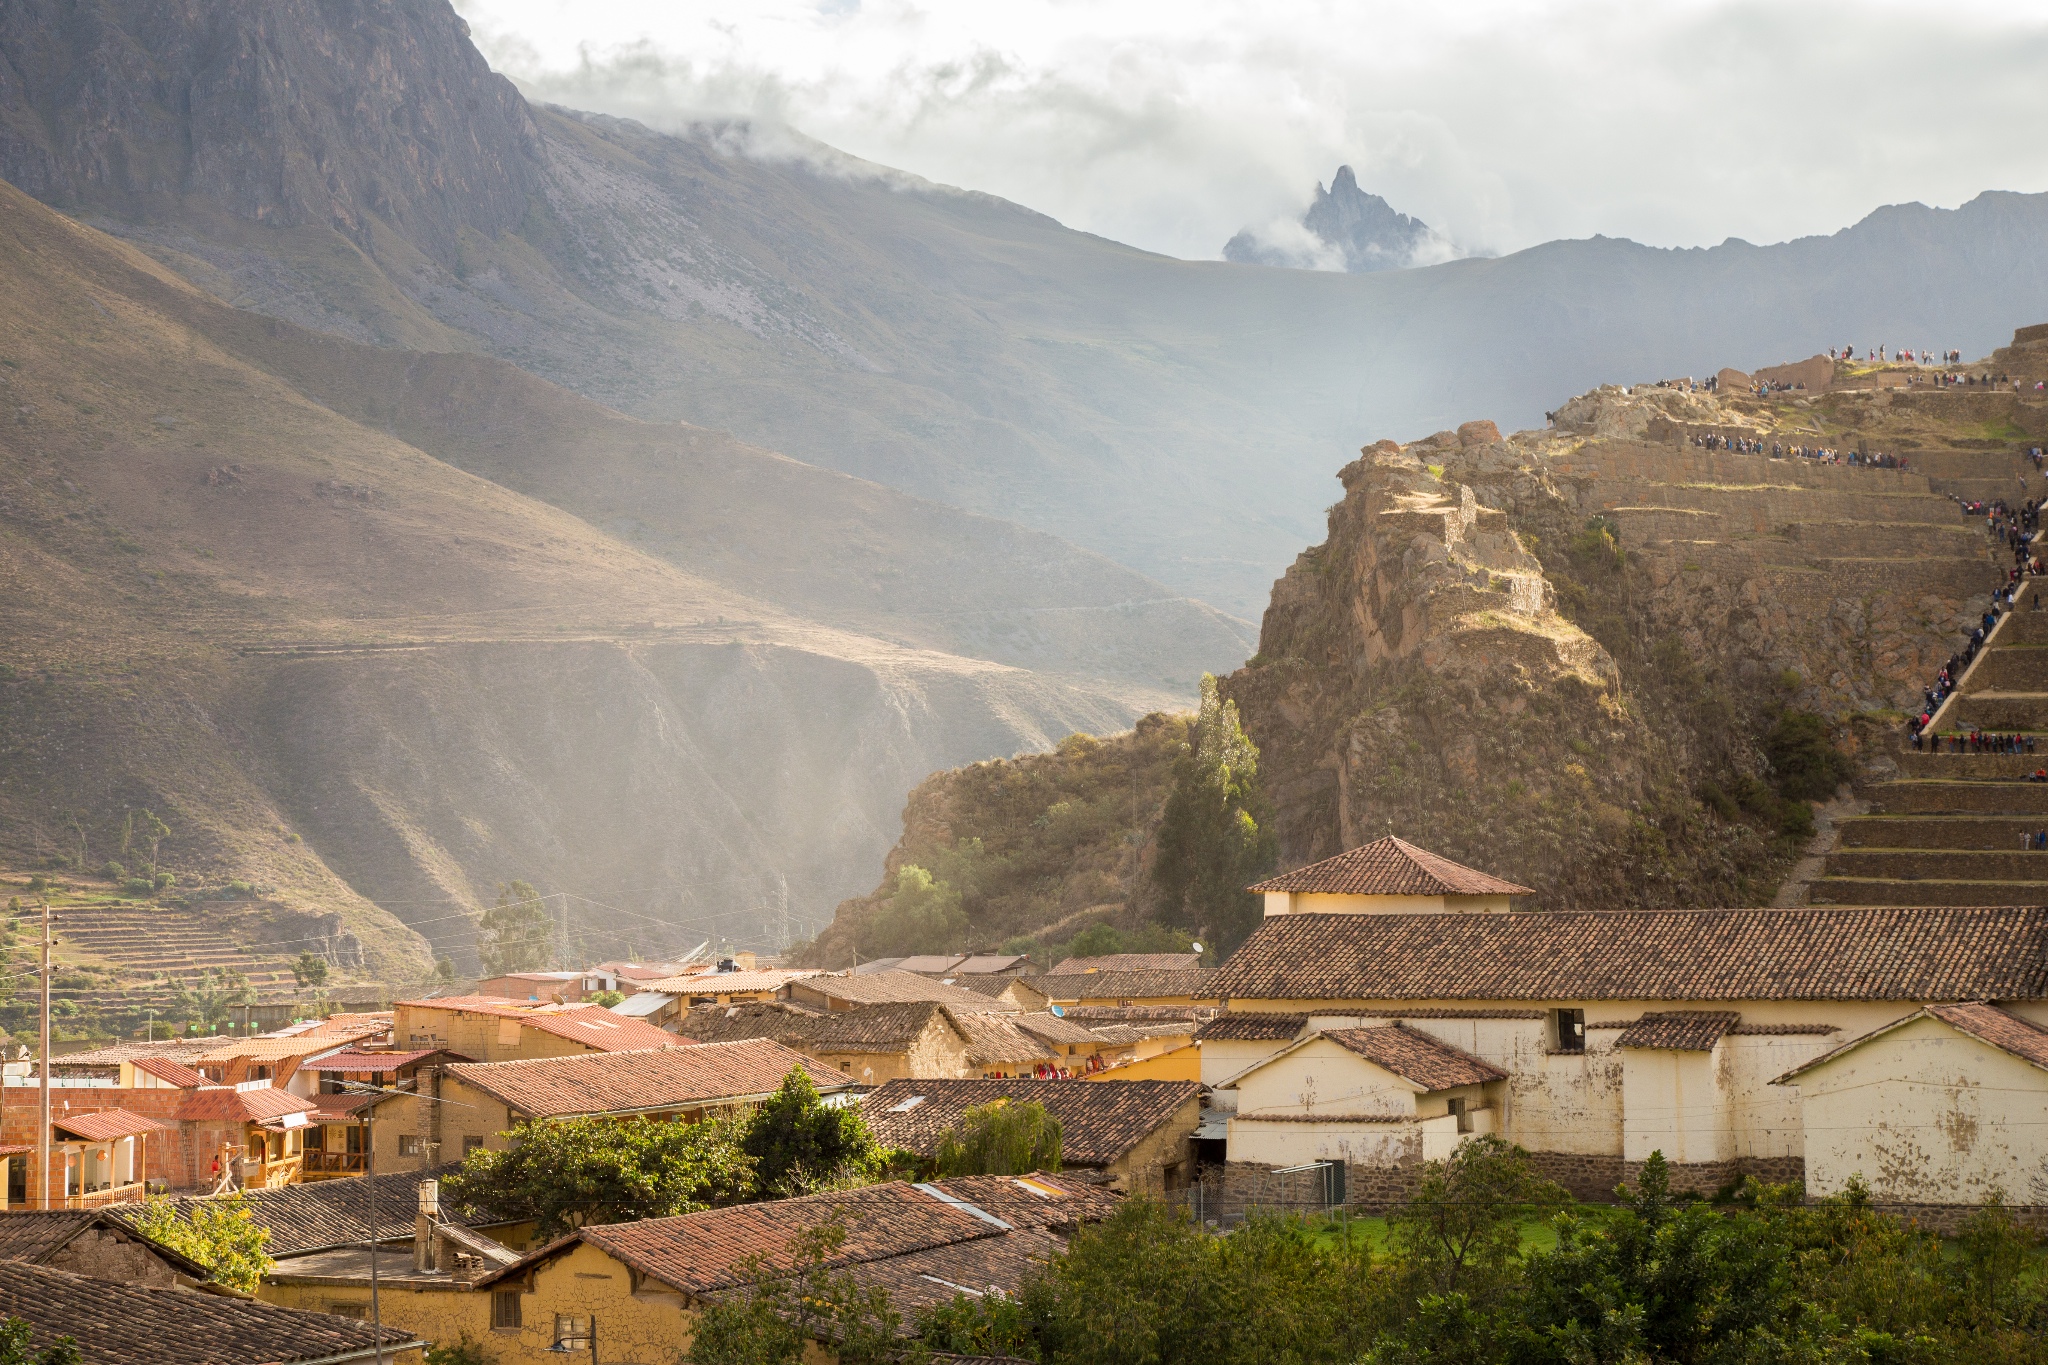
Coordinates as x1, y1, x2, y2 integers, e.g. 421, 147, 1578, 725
0, 175, 1174, 1019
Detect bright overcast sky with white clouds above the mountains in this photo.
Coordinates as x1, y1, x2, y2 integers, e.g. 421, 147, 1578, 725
457, 0, 2048, 258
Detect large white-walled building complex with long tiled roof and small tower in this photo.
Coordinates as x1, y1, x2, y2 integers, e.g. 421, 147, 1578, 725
1202, 839, 2048, 1205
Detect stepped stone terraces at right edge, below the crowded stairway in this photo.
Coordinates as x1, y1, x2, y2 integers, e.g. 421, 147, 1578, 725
1806, 511, 2048, 905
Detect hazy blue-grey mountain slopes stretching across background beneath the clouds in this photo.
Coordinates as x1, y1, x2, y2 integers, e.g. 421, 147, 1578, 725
0, 0, 2048, 618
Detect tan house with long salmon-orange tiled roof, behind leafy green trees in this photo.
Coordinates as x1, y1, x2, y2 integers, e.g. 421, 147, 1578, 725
373, 1038, 854, 1171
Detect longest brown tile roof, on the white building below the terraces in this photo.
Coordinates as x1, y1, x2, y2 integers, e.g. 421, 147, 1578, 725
1219, 907, 2048, 1001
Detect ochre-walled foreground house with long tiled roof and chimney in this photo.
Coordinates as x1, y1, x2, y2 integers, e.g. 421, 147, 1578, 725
262, 1175, 1114, 1365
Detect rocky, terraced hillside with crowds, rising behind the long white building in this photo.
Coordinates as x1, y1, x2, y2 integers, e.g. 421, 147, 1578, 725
821, 339, 2048, 952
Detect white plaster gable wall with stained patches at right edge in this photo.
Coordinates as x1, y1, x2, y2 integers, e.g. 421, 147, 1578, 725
1798, 1019, 2048, 1203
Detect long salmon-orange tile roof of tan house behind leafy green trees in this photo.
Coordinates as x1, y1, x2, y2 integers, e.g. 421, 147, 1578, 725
446, 1038, 852, 1117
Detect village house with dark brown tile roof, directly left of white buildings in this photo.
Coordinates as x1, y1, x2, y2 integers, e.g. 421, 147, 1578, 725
860, 1081, 1202, 1195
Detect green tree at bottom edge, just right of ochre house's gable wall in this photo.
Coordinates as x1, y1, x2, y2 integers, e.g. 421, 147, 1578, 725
682, 1224, 913, 1365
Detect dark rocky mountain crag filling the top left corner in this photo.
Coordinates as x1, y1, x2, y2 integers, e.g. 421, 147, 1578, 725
0, 0, 541, 264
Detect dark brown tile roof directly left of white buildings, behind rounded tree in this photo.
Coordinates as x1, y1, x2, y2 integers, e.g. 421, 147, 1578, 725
860, 1081, 1202, 1166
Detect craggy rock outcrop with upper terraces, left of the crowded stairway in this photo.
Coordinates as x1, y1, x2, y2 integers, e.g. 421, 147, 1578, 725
1227, 368, 2032, 907
